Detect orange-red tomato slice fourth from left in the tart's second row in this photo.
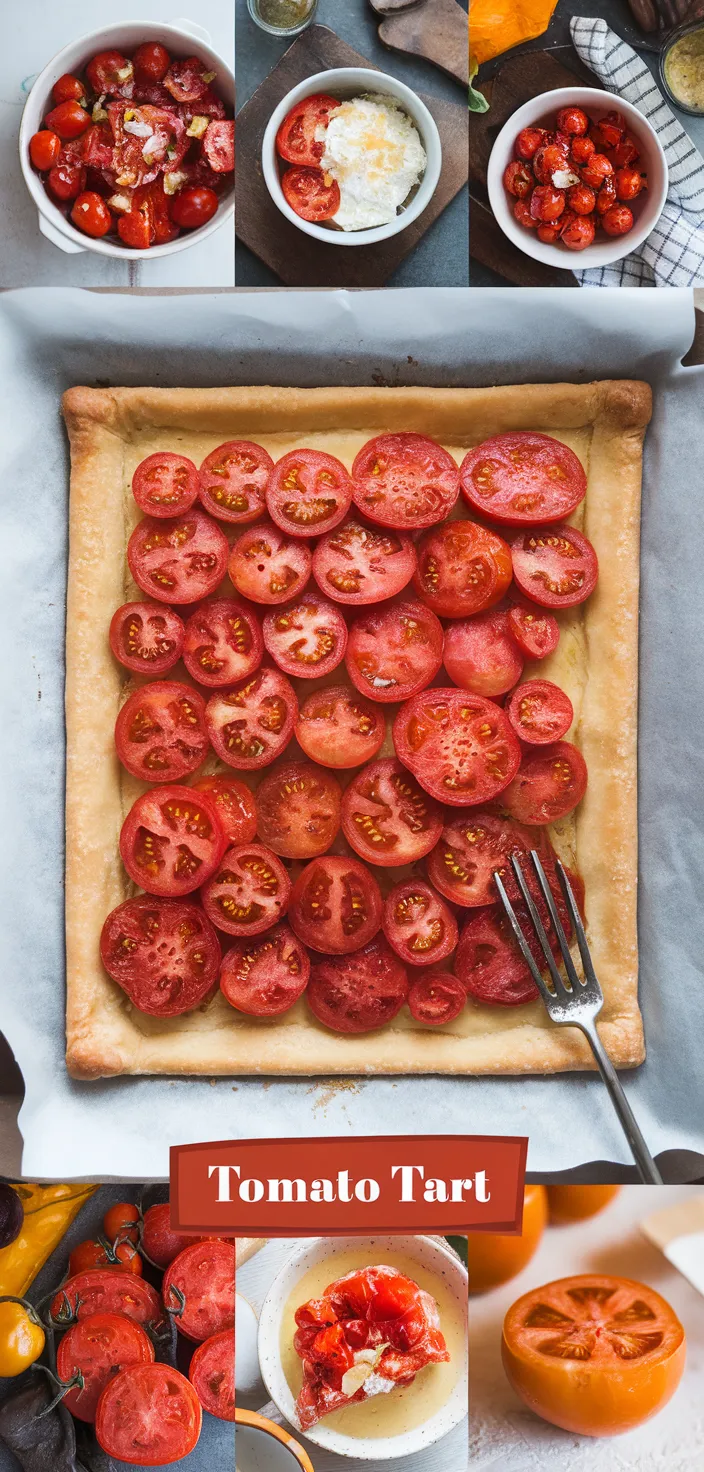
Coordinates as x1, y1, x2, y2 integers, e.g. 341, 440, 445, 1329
414, 520, 513, 618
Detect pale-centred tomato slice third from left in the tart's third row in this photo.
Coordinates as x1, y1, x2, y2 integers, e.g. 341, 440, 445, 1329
262, 593, 348, 680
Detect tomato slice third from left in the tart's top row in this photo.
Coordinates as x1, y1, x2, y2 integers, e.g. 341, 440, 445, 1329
267, 449, 352, 537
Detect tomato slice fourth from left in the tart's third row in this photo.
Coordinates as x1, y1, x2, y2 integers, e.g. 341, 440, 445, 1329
345, 602, 443, 705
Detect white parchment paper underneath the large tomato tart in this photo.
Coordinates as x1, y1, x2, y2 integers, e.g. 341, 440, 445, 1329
0, 289, 704, 1179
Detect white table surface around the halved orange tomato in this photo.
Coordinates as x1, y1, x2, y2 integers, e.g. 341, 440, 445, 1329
470, 1185, 704, 1472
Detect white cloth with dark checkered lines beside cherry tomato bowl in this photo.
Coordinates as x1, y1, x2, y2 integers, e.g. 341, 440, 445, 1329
571, 16, 704, 286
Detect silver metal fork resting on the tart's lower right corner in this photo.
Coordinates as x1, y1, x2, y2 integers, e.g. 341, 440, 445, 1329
493, 849, 663, 1185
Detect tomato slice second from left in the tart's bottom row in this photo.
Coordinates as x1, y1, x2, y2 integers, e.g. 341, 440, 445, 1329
219, 924, 311, 1017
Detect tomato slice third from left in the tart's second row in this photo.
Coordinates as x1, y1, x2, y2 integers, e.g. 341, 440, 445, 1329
312, 517, 415, 604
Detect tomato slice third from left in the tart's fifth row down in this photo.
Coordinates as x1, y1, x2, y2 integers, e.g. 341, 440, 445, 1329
256, 761, 342, 858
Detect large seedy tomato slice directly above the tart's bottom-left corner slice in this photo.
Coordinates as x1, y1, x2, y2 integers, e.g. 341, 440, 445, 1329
119, 786, 227, 899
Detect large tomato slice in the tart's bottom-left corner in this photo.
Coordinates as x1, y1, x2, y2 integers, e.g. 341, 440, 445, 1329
100, 895, 221, 1017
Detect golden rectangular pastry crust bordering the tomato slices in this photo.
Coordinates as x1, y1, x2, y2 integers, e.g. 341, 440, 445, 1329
63, 381, 651, 1079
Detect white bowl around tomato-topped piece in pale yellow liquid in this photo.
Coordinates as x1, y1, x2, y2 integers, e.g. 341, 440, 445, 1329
259, 1236, 468, 1463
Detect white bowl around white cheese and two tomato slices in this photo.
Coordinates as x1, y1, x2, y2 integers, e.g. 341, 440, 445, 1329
262, 66, 442, 246
